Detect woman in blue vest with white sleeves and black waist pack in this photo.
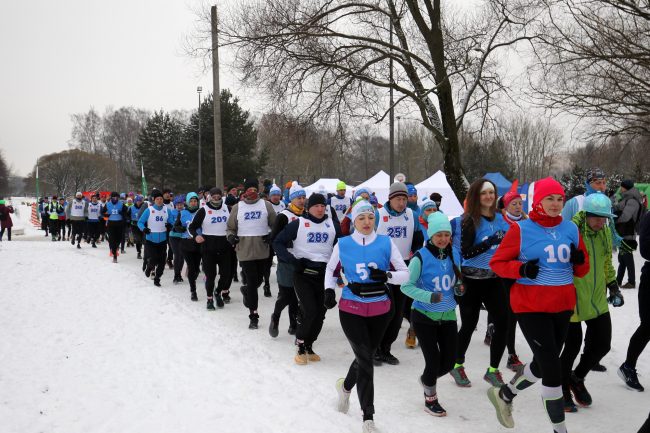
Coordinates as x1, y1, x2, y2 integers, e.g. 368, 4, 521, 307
325, 200, 408, 433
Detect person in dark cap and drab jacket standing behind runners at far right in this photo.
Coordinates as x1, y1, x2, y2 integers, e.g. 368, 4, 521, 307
614, 179, 645, 289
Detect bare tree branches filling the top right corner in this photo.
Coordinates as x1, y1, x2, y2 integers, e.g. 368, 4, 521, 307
530, 0, 650, 138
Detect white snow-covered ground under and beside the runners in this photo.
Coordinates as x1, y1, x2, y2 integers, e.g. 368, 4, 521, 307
0, 232, 650, 433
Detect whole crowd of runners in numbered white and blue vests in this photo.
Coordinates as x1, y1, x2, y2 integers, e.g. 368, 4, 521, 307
36, 169, 650, 433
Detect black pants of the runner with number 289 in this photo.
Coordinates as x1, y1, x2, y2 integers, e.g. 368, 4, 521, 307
293, 273, 327, 346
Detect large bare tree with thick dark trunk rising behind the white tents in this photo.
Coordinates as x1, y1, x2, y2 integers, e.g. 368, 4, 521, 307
213, 0, 538, 194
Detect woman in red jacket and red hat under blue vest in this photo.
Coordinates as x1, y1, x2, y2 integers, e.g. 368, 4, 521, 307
488, 177, 589, 433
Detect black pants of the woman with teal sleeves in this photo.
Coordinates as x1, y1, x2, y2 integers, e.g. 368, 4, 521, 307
411, 310, 458, 386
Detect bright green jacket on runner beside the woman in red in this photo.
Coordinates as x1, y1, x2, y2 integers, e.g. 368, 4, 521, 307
571, 211, 616, 322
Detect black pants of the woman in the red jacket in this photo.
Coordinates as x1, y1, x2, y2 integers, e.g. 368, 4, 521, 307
517, 311, 573, 387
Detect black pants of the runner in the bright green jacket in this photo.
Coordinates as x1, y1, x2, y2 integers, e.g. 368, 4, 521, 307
561, 313, 612, 391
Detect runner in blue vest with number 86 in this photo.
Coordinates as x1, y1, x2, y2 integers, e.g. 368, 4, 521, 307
138, 190, 172, 287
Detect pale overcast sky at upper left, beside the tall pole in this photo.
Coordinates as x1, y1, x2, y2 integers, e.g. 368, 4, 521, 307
0, 0, 250, 175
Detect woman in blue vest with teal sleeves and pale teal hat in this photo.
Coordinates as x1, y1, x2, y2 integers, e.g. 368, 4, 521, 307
402, 212, 464, 416
